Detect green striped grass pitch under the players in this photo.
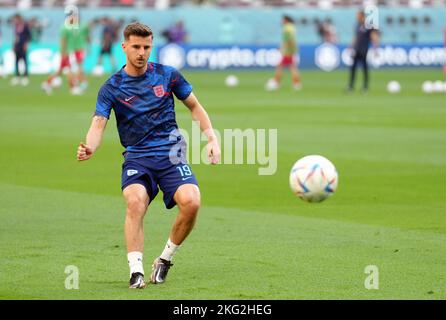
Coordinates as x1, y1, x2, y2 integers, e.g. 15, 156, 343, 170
0, 69, 446, 299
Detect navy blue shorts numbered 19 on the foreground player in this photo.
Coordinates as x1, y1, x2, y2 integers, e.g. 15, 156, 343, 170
121, 155, 198, 209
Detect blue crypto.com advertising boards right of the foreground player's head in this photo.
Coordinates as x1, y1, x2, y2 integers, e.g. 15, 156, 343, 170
157, 43, 446, 72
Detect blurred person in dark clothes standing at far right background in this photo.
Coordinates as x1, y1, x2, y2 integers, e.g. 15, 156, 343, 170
347, 11, 379, 93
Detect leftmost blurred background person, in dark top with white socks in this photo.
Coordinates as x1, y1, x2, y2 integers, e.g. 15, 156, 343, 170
11, 14, 31, 86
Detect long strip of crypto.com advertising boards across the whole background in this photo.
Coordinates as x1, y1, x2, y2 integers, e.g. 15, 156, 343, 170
0, 43, 446, 74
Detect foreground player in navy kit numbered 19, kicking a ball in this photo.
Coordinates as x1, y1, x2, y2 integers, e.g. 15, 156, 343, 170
77, 22, 220, 288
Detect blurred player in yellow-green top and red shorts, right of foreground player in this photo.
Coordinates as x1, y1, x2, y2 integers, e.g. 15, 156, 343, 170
266, 15, 302, 90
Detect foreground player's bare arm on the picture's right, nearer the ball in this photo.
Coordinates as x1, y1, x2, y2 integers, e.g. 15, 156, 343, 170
183, 92, 221, 164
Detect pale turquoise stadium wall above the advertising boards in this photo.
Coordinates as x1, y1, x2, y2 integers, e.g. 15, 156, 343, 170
0, 7, 446, 45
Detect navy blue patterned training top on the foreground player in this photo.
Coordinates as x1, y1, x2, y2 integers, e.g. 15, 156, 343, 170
95, 63, 192, 158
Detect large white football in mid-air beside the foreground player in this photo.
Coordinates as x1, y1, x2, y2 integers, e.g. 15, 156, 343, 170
290, 155, 338, 202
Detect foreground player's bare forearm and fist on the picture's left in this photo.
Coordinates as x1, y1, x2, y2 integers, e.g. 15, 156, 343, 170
77, 115, 108, 161
